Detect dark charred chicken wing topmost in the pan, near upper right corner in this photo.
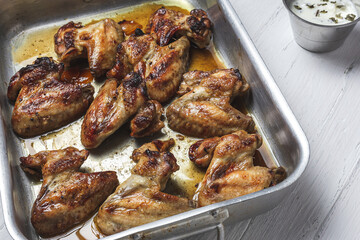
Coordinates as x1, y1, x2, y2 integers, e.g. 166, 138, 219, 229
147, 7, 212, 48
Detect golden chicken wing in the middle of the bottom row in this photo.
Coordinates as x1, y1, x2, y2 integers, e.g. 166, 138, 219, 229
95, 139, 192, 235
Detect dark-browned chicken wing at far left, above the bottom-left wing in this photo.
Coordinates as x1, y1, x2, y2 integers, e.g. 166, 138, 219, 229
8, 57, 94, 137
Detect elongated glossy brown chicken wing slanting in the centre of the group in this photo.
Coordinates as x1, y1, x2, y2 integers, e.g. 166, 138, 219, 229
81, 72, 147, 148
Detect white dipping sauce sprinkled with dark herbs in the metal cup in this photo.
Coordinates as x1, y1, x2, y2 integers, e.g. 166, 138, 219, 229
290, 0, 358, 25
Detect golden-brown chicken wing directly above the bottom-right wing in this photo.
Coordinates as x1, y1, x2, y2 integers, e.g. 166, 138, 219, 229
166, 69, 255, 138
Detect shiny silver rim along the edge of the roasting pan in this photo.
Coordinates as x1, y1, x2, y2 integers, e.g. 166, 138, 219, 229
0, 0, 310, 240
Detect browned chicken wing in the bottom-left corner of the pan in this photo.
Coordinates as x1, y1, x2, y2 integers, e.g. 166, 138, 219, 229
20, 147, 119, 237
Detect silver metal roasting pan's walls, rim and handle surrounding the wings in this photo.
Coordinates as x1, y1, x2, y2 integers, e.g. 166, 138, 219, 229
0, 0, 309, 239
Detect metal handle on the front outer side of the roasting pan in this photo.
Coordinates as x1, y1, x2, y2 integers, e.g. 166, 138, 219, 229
131, 208, 229, 240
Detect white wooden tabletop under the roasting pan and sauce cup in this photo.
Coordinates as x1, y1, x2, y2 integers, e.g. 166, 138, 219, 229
0, 0, 360, 240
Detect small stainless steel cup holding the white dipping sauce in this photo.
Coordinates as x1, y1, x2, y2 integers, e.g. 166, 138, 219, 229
283, 0, 360, 52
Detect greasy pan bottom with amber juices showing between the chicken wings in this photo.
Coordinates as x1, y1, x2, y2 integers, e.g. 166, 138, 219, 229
12, 1, 276, 240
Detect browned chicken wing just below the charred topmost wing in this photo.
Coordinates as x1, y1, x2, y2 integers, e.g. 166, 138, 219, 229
107, 33, 190, 103
